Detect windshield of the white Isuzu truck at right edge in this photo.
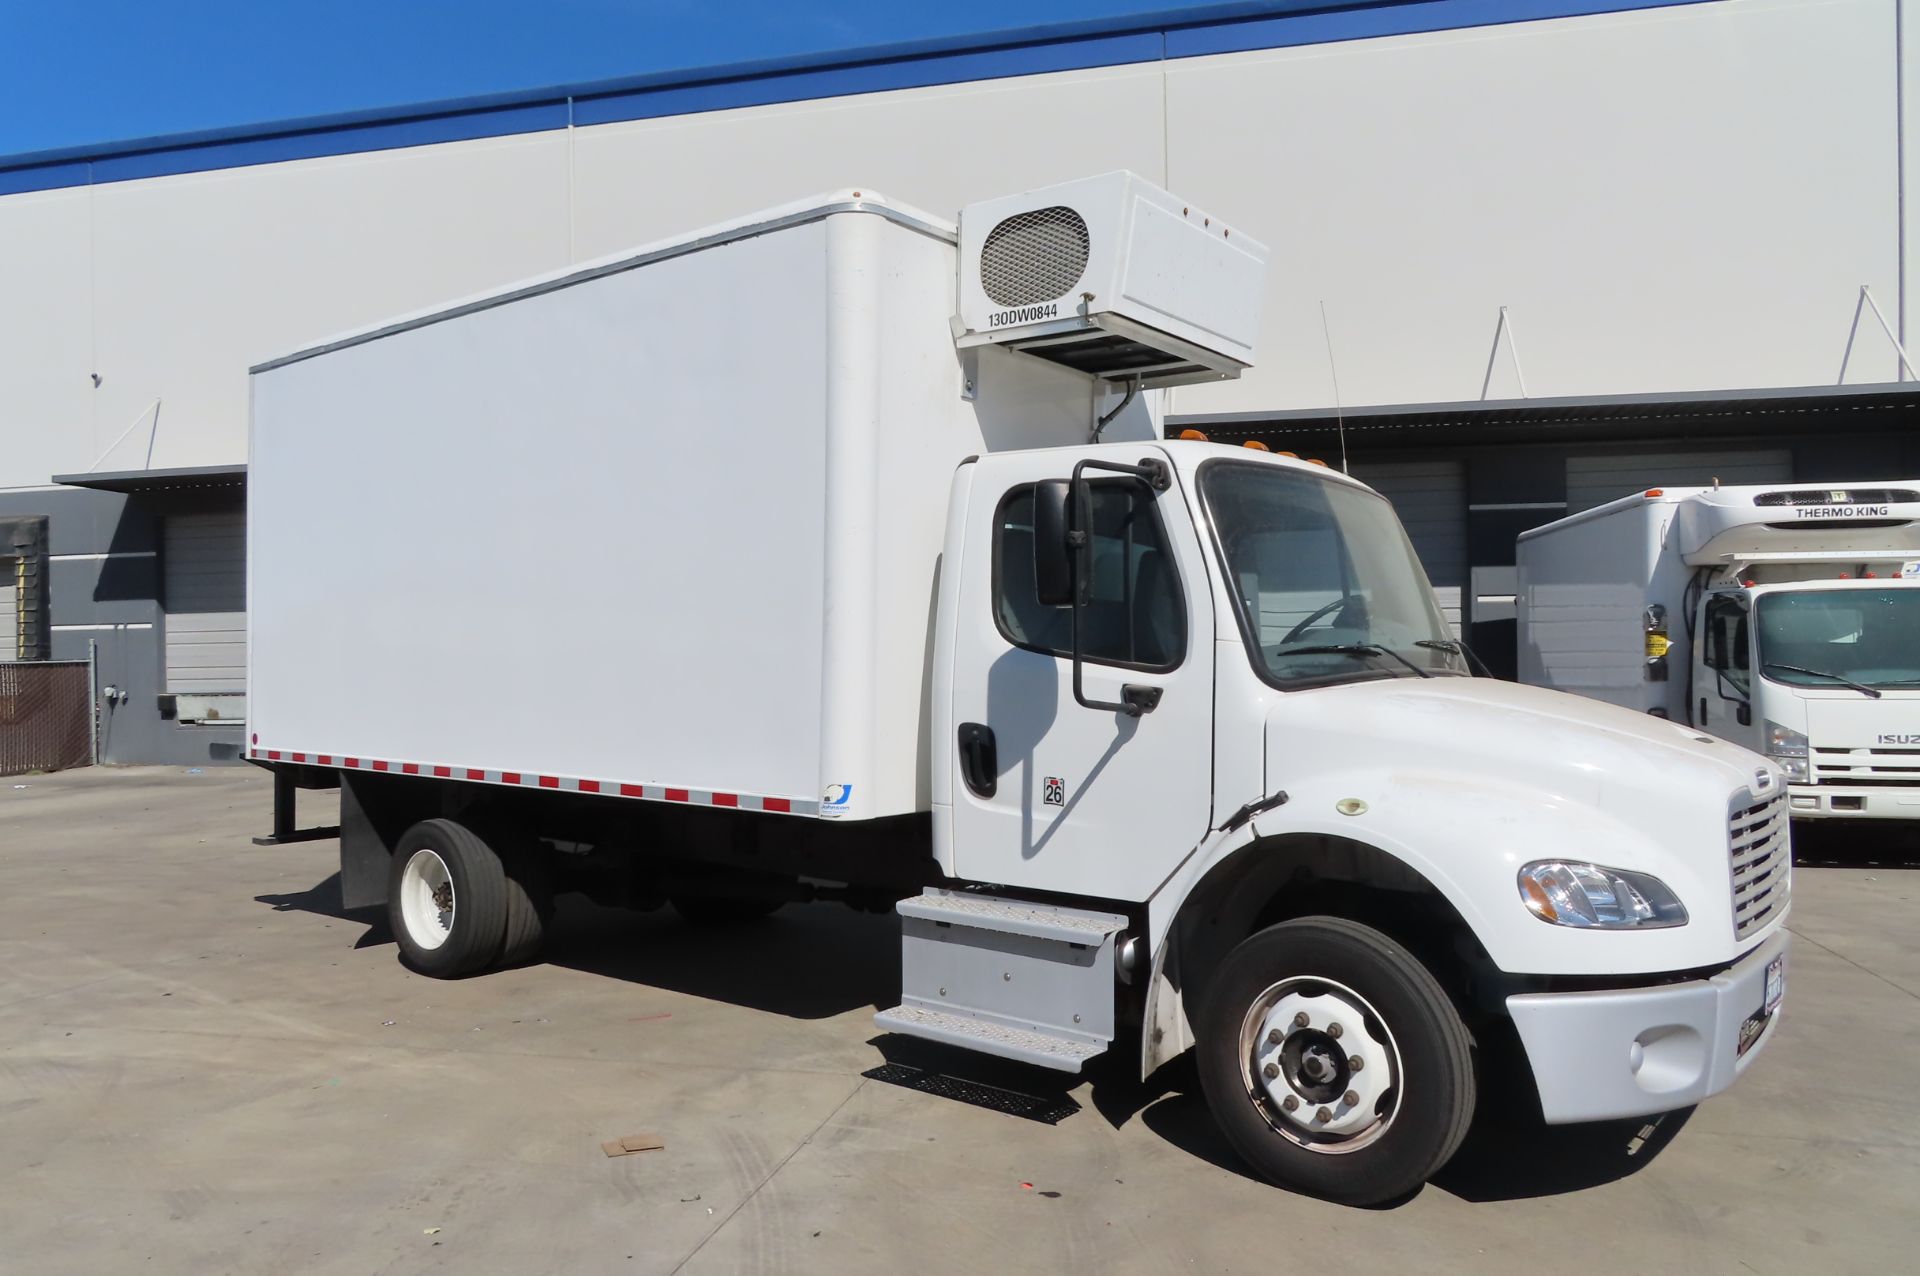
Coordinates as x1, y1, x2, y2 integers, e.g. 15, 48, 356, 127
1759, 585, 1920, 687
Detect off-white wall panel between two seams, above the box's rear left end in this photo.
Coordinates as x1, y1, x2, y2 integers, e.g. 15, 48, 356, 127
86, 132, 566, 482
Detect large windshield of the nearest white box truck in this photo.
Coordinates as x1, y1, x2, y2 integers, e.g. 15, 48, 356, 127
1200, 461, 1467, 683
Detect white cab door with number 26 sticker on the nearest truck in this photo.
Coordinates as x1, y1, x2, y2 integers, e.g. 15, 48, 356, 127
935, 451, 1213, 900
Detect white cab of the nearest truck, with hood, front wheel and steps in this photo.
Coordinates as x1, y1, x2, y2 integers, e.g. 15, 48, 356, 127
906, 439, 1789, 1199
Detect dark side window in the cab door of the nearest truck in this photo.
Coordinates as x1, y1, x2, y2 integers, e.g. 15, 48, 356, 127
993, 480, 1187, 670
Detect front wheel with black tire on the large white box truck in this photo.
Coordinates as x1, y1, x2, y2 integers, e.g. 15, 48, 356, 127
1196, 917, 1475, 1205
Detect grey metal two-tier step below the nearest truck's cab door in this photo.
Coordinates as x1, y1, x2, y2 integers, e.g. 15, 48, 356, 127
874, 890, 1127, 1073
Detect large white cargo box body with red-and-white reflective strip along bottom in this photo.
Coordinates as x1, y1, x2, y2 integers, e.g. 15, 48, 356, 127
248, 192, 1152, 819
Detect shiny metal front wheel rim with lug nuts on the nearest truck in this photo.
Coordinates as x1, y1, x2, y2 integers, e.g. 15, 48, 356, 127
1238, 975, 1405, 1155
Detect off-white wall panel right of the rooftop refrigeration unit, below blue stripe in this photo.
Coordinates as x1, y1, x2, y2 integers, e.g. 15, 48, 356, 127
1167, 0, 1899, 413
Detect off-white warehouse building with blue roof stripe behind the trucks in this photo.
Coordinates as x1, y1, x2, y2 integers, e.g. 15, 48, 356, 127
0, 0, 1920, 762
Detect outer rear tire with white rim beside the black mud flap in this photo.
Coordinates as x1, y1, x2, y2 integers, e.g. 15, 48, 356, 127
386, 819, 524, 979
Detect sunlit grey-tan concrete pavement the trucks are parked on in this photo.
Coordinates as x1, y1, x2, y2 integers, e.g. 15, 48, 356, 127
0, 768, 1920, 1276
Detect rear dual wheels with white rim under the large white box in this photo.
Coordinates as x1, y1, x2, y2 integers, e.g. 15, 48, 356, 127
386, 819, 553, 979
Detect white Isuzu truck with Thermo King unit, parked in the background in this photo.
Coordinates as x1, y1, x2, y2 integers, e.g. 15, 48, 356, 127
1515, 480, 1920, 819
